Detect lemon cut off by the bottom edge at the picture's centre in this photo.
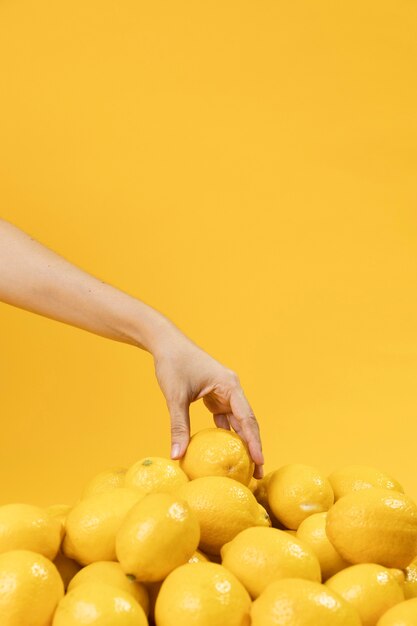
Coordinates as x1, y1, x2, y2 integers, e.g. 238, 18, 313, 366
155, 563, 251, 626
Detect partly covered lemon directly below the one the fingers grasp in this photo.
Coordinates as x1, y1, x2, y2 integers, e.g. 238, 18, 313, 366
178, 476, 269, 554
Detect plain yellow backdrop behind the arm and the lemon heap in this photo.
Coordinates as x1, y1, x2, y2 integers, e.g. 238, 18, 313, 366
0, 0, 417, 504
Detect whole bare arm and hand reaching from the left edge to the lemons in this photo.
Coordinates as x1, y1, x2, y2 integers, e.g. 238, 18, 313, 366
0, 219, 264, 478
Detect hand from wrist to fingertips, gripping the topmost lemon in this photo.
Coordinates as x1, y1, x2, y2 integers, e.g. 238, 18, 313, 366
154, 329, 264, 478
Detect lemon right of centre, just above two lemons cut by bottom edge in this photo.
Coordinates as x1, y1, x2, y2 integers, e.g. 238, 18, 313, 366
221, 527, 321, 598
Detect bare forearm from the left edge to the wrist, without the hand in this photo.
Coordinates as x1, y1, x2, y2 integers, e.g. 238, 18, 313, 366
0, 220, 178, 353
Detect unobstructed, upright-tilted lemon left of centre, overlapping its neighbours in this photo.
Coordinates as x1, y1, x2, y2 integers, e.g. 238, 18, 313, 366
116, 493, 200, 582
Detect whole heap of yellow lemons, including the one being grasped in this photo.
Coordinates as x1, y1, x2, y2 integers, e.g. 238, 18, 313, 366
0, 428, 417, 626
